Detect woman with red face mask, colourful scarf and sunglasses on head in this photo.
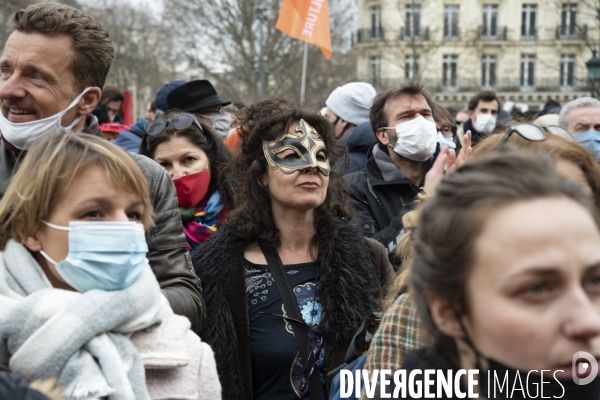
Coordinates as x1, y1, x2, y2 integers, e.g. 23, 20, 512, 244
140, 111, 229, 250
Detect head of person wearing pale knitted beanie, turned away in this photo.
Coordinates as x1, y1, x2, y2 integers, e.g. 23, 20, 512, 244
325, 82, 377, 137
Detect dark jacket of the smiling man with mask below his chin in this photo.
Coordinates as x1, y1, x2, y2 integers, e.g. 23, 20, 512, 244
0, 116, 205, 332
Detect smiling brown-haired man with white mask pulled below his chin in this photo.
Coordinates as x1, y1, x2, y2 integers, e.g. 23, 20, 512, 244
0, 3, 204, 329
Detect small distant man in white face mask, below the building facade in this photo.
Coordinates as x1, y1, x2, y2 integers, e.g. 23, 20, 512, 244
463, 91, 500, 143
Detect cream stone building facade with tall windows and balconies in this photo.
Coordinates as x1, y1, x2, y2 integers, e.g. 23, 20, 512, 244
353, 0, 600, 110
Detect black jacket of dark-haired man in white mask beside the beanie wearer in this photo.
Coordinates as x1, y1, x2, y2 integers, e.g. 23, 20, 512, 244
345, 144, 439, 263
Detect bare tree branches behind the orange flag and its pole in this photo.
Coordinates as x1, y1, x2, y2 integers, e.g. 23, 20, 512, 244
159, 0, 356, 102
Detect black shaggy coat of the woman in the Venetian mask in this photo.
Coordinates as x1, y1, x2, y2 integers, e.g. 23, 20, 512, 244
192, 216, 394, 400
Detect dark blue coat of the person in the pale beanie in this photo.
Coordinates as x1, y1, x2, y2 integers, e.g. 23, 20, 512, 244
336, 121, 377, 175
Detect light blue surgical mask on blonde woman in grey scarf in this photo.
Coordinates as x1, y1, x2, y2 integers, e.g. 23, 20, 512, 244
40, 221, 148, 292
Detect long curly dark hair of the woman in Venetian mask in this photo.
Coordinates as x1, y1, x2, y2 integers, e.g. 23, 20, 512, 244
227, 100, 352, 248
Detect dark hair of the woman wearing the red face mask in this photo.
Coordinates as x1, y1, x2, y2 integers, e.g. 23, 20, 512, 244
140, 111, 231, 194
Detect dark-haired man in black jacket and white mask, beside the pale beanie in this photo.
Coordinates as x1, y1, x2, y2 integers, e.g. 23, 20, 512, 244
346, 82, 439, 261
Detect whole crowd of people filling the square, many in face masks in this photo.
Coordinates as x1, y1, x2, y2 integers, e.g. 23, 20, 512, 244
0, 3, 600, 400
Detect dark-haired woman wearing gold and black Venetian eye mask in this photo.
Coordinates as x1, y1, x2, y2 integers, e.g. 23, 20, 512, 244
192, 101, 393, 400
